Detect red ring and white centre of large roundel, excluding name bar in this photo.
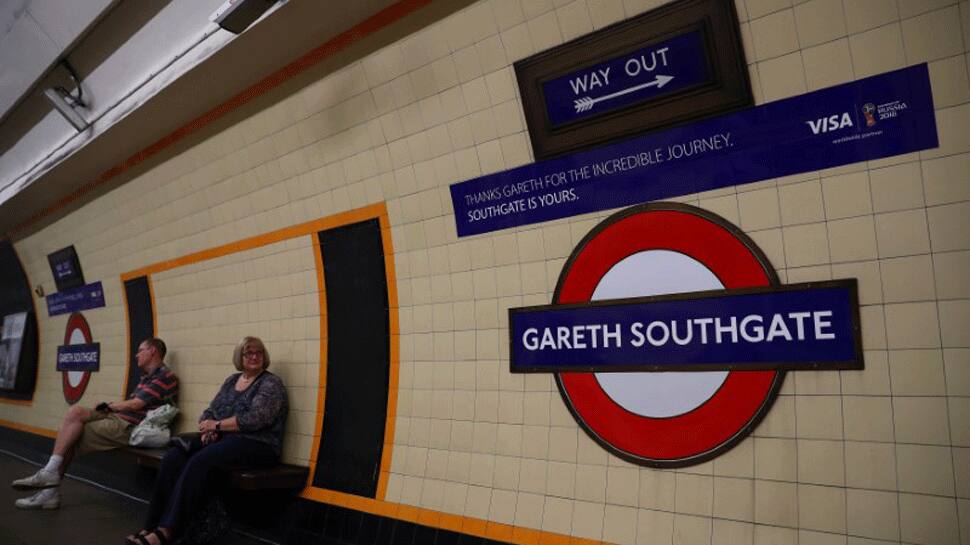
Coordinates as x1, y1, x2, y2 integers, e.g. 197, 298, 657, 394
553, 203, 785, 467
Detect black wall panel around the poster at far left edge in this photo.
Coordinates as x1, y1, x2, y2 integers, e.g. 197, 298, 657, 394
0, 240, 38, 400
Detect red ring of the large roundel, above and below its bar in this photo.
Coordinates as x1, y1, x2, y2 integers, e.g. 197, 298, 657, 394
554, 204, 784, 467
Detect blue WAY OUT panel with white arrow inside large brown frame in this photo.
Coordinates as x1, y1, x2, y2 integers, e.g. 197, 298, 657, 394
542, 30, 711, 128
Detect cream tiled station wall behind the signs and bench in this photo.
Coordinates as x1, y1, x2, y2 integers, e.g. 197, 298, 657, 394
0, 0, 970, 545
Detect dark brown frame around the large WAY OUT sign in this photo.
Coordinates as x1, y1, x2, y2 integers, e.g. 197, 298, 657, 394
515, 0, 754, 160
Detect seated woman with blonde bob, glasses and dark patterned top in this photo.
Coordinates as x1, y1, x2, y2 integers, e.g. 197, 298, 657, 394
125, 337, 288, 545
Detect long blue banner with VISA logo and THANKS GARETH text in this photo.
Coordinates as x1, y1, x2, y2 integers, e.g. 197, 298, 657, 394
451, 64, 939, 236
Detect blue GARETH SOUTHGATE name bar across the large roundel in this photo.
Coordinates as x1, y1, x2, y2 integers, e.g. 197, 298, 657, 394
509, 279, 863, 373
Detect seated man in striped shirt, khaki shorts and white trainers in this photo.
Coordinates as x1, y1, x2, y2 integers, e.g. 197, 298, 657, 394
13, 337, 178, 509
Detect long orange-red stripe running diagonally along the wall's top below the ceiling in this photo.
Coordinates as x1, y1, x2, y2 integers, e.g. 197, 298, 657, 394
10, 0, 431, 238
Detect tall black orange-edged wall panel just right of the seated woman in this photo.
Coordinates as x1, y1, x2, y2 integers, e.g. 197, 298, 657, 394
313, 219, 390, 497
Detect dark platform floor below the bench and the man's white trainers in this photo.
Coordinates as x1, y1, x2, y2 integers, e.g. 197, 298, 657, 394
0, 453, 272, 545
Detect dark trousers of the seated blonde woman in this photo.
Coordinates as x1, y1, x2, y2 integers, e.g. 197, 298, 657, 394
145, 435, 279, 534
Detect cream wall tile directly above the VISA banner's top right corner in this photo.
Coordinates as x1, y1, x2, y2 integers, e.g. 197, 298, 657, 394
902, 6, 965, 64
